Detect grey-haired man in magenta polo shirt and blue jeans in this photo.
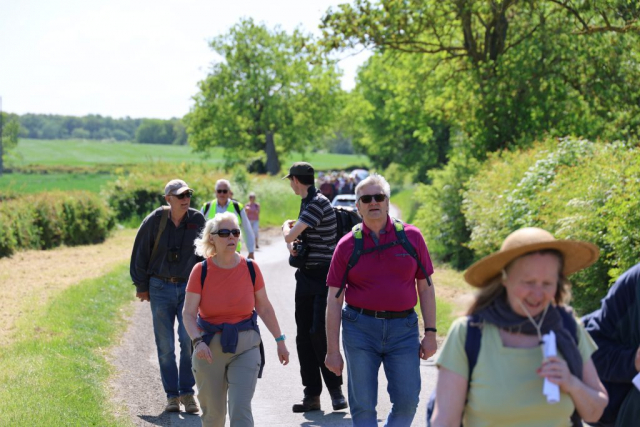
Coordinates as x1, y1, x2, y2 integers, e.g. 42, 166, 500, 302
325, 174, 437, 427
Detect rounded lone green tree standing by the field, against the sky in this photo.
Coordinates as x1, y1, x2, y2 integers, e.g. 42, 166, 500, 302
185, 19, 340, 175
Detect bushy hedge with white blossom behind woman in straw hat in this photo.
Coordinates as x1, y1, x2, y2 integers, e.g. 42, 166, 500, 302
463, 138, 640, 313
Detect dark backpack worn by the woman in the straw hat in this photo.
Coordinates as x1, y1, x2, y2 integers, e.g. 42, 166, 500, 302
427, 309, 581, 427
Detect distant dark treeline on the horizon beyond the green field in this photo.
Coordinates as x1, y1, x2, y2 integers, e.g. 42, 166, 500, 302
16, 114, 187, 145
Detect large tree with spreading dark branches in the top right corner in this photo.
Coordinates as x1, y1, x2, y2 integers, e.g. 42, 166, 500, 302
323, 0, 640, 158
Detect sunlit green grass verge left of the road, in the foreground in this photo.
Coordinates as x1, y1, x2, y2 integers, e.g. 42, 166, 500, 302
0, 265, 134, 426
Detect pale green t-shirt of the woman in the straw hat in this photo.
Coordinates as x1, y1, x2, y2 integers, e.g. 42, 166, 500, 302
437, 317, 597, 427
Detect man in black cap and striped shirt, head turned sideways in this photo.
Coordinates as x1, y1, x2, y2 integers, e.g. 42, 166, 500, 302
282, 162, 347, 412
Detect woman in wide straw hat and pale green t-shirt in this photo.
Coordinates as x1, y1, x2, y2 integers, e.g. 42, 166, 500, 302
432, 228, 608, 427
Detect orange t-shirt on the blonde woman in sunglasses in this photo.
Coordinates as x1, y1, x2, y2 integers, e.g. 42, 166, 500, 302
187, 257, 264, 325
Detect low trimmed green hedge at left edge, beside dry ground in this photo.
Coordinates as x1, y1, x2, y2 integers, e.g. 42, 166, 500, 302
0, 191, 115, 257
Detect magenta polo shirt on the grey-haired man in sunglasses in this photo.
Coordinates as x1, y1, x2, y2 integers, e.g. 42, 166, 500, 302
327, 217, 433, 311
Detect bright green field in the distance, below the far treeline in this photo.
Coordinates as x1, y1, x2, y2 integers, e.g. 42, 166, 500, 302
14, 139, 369, 170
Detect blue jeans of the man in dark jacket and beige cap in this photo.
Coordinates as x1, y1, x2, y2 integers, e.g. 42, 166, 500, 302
149, 277, 196, 398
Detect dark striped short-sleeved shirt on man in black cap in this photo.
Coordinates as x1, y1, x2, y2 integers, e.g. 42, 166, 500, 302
298, 185, 338, 267
